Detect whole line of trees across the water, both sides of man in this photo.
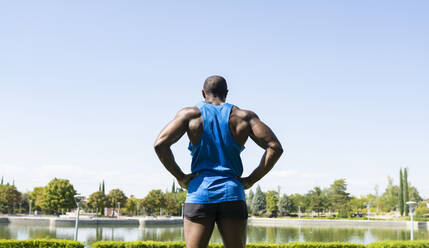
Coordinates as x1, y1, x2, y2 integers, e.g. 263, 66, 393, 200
0, 168, 429, 218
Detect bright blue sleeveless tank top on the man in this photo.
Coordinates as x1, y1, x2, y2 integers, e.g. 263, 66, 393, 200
186, 102, 246, 204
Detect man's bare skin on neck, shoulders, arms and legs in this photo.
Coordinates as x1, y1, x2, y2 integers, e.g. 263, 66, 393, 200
155, 90, 283, 248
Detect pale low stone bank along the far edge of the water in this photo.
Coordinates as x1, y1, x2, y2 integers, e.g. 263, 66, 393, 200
0, 216, 429, 231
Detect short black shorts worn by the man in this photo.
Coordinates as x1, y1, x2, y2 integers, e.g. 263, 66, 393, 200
183, 201, 248, 220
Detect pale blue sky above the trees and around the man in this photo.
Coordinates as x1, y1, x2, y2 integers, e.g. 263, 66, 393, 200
0, 1, 429, 197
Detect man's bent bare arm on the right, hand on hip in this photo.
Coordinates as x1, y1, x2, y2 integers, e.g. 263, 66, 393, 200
240, 111, 283, 189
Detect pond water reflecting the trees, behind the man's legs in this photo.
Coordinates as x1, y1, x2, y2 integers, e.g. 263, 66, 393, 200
0, 223, 429, 245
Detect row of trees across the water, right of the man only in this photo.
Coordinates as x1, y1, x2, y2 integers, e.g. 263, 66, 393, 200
246, 168, 429, 218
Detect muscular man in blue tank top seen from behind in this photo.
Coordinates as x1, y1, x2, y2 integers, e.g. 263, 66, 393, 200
155, 76, 283, 248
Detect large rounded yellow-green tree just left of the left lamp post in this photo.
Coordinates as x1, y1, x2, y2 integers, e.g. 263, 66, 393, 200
42, 178, 76, 214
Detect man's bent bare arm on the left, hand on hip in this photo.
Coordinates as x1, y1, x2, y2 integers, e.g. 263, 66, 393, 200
154, 108, 196, 188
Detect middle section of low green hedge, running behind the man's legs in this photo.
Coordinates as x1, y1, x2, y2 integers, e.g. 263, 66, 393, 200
92, 241, 365, 248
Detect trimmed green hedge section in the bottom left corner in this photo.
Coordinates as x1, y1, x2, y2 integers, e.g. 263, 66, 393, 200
0, 239, 84, 248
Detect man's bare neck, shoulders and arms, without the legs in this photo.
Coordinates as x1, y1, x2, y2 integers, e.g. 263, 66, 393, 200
154, 90, 283, 189
